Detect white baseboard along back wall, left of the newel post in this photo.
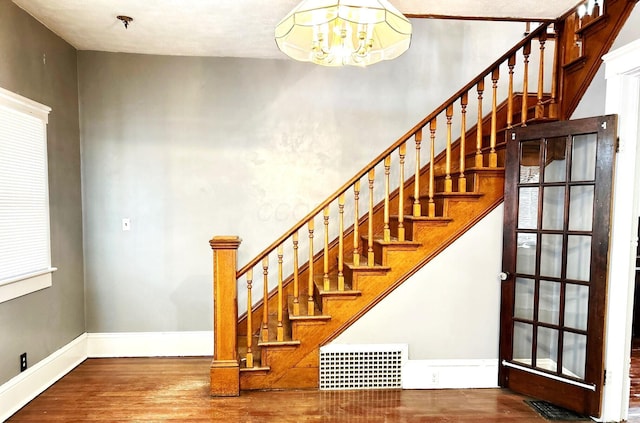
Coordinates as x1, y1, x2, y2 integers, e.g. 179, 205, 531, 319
87, 331, 213, 358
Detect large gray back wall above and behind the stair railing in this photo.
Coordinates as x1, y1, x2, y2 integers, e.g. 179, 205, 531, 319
78, 20, 522, 332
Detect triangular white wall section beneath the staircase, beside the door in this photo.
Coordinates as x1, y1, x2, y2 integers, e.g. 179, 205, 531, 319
333, 205, 504, 360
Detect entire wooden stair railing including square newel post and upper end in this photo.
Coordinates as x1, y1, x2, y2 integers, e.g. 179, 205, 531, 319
211, 0, 637, 395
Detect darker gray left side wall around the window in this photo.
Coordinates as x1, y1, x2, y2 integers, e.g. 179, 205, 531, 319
0, 0, 85, 384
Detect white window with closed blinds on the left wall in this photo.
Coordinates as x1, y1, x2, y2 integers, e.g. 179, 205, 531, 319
0, 88, 56, 302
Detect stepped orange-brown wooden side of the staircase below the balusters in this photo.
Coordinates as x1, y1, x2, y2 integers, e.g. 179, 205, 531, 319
240, 169, 504, 390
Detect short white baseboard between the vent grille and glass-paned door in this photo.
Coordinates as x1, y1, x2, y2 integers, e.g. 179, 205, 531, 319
402, 359, 498, 389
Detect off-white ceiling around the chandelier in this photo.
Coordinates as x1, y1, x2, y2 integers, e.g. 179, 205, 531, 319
13, 0, 577, 58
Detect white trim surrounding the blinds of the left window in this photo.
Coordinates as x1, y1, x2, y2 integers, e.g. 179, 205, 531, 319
0, 87, 57, 303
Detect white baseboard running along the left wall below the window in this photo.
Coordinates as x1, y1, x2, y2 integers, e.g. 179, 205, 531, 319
0, 334, 87, 421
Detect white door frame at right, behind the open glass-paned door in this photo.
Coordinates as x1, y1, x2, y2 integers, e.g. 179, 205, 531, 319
601, 39, 640, 421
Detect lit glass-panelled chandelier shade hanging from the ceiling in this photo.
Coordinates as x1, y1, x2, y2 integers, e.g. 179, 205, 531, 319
275, 0, 411, 66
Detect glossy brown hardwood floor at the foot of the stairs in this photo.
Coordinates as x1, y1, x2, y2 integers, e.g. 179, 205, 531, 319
8, 358, 596, 423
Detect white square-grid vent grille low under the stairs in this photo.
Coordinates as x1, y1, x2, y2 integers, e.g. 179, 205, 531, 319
320, 344, 408, 390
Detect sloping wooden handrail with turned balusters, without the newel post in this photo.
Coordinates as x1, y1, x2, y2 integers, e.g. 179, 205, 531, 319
230, 19, 556, 366
